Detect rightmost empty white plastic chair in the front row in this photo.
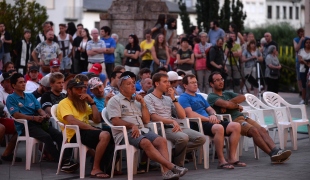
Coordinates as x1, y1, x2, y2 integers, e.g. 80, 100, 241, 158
263, 92, 310, 150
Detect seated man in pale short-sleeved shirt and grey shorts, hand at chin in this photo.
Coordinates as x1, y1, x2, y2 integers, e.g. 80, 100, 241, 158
107, 76, 187, 179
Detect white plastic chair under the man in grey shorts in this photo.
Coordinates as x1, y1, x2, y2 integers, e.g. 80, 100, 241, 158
101, 108, 138, 180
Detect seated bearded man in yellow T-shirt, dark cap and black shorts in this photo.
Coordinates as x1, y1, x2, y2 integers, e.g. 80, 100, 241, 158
57, 77, 113, 178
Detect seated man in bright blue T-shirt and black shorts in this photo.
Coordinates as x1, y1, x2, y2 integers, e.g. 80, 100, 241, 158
179, 74, 246, 169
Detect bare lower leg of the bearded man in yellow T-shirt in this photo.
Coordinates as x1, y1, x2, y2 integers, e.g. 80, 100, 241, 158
90, 131, 111, 177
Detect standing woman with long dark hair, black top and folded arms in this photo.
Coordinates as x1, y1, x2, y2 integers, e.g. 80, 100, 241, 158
124, 34, 141, 75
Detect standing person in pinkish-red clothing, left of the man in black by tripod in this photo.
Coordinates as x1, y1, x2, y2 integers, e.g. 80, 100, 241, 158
194, 32, 212, 94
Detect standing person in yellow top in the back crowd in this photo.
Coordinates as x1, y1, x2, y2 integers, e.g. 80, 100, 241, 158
140, 29, 155, 69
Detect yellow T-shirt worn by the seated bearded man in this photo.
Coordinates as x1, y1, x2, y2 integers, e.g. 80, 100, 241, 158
56, 98, 92, 142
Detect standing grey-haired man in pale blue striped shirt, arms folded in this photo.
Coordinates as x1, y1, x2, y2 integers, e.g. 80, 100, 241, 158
83, 28, 106, 74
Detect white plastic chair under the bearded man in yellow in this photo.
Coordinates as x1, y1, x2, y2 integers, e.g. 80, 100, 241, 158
51, 104, 88, 178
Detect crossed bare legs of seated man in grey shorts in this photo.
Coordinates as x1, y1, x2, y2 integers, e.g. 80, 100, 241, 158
140, 137, 174, 172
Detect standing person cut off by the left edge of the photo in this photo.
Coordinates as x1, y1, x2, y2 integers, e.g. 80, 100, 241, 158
0, 22, 12, 64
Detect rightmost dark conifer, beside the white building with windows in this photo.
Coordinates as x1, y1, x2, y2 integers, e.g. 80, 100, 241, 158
231, 0, 246, 32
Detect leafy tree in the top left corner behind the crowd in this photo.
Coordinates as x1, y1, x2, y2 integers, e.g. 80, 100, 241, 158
0, 0, 48, 59
